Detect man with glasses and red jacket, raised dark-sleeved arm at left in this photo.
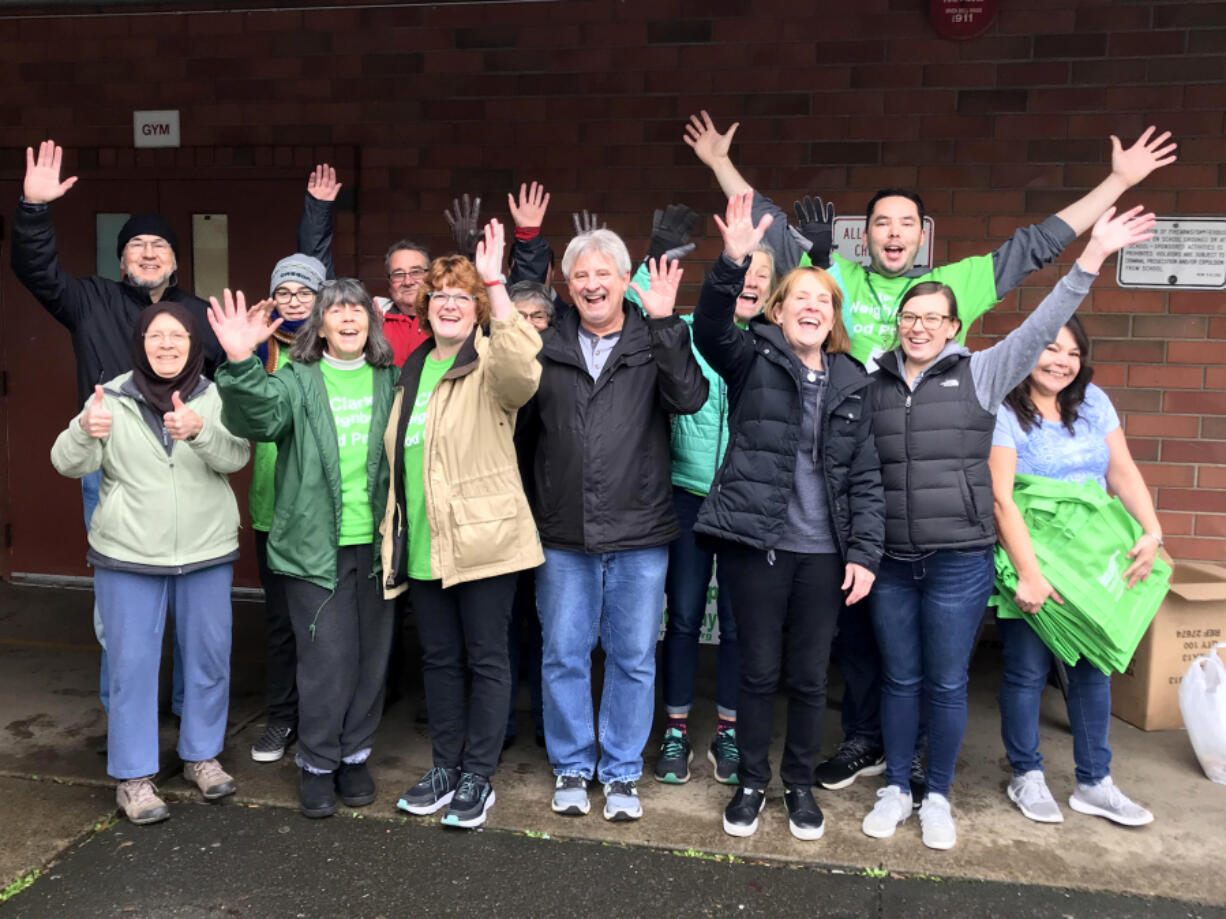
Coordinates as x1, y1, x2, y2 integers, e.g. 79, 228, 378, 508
298, 163, 430, 366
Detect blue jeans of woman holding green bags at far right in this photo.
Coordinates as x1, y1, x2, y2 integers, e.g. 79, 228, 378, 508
997, 619, 1111, 785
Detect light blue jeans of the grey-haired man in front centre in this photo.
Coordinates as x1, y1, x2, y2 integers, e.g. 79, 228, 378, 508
537, 545, 668, 783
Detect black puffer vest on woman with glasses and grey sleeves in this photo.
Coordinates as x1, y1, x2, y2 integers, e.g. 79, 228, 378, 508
868, 349, 996, 558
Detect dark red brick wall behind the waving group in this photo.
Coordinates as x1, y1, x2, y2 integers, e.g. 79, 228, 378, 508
0, 0, 1226, 561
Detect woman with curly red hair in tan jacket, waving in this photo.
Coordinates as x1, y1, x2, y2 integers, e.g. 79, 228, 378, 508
381, 221, 544, 827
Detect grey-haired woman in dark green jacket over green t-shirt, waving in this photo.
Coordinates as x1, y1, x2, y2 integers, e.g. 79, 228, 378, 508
210, 278, 397, 817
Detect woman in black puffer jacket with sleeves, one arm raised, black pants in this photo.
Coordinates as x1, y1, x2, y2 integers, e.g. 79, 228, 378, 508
694, 192, 885, 839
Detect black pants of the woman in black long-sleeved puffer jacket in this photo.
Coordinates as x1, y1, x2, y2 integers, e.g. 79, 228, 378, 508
720, 543, 843, 789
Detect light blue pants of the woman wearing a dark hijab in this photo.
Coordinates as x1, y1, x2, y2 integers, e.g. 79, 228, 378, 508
93, 564, 234, 779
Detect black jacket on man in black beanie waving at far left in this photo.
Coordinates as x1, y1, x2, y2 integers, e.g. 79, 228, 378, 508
12, 202, 226, 406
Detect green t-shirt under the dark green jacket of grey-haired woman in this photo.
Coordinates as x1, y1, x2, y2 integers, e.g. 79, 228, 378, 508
319, 360, 375, 545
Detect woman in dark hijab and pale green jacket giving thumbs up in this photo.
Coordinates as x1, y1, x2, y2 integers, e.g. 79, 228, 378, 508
51, 303, 250, 823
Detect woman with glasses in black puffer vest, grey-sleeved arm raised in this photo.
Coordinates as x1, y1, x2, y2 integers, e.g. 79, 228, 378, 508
862, 207, 1154, 849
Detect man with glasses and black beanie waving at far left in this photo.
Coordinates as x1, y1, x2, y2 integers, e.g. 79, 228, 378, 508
12, 140, 224, 735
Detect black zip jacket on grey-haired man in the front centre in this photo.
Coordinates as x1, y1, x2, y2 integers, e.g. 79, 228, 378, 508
520, 300, 707, 553
